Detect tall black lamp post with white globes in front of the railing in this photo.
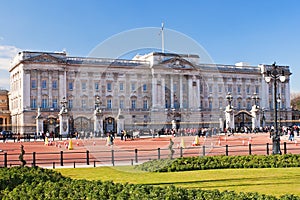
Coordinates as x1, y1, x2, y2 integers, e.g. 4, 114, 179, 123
264, 62, 286, 154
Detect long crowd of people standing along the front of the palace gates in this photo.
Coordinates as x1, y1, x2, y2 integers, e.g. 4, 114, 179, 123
2, 125, 300, 143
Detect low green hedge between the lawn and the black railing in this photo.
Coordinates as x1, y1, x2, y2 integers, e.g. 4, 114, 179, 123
136, 154, 300, 172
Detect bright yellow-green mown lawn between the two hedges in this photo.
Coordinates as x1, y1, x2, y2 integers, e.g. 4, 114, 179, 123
56, 166, 300, 196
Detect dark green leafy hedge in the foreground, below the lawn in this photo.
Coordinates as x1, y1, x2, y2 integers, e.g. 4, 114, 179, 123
0, 167, 300, 200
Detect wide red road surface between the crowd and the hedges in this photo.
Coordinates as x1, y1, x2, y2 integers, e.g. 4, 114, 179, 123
0, 133, 300, 167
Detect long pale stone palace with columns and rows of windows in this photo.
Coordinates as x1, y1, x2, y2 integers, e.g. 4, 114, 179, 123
9, 51, 292, 134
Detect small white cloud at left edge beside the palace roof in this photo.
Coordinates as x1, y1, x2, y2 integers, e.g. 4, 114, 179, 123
0, 45, 20, 70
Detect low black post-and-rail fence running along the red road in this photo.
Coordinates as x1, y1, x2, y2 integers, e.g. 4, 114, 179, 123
0, 142, 300, 168
